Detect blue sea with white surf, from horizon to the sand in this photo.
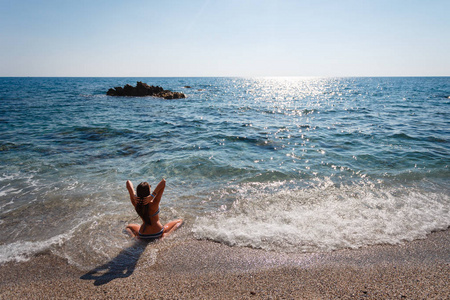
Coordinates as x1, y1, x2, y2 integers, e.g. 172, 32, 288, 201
0, 77, 450, 268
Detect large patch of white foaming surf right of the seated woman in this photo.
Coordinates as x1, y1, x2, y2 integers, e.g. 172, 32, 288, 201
193, 179, 450, 252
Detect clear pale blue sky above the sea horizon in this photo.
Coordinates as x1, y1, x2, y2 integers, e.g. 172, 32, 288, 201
0, 0, 450, 77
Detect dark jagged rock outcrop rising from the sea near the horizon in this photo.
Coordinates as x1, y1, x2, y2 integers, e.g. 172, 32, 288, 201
106, 81, 186, 99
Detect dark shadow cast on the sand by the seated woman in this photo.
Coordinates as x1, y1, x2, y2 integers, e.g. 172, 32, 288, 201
80, 240, 151, 286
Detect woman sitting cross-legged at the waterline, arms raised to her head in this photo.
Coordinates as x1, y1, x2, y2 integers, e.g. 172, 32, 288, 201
127, 179, 183, 239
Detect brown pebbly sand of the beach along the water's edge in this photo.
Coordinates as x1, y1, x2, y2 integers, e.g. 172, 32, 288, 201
0, 230, 450, 299
